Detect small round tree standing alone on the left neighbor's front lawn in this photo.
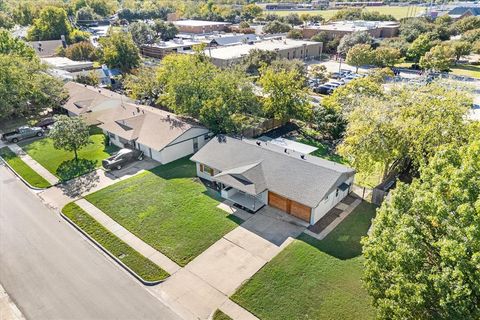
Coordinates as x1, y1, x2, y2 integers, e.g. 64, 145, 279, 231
48, 115, 90, 161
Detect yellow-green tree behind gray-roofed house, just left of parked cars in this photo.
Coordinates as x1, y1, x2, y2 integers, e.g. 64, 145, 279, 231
258, 67, 311, 121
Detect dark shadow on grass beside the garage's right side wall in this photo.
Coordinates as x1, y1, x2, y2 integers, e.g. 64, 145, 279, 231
297, 202, 376, 260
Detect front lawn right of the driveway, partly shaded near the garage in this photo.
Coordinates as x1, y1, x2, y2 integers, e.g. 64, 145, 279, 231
231, 203, 375, 320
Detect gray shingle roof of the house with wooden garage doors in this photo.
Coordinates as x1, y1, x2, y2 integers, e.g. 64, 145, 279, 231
191, 136, 355, 208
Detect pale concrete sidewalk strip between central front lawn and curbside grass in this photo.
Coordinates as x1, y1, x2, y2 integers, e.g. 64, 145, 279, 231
75, 199, 180, 275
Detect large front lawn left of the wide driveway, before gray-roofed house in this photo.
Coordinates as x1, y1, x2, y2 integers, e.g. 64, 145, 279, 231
86, 158, 240, 266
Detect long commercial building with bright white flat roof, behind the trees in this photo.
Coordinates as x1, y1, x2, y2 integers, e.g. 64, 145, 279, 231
201, 39, 322, 67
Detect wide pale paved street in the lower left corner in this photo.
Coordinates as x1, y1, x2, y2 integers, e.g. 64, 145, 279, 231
0, 165, 179, 320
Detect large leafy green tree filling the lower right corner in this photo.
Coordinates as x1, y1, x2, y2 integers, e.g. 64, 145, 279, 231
363, 140, 480, 320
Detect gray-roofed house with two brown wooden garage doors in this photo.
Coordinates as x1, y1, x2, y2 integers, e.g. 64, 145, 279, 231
191, 136, 355, 224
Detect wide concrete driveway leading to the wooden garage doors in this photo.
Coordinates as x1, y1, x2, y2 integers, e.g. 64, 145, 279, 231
154, 207, 306, 319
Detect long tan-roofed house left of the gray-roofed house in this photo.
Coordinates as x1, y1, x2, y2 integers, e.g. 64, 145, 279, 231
64, 82, 211, 164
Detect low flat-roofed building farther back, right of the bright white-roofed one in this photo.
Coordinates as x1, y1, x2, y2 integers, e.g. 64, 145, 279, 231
301, 20, 400, 39
